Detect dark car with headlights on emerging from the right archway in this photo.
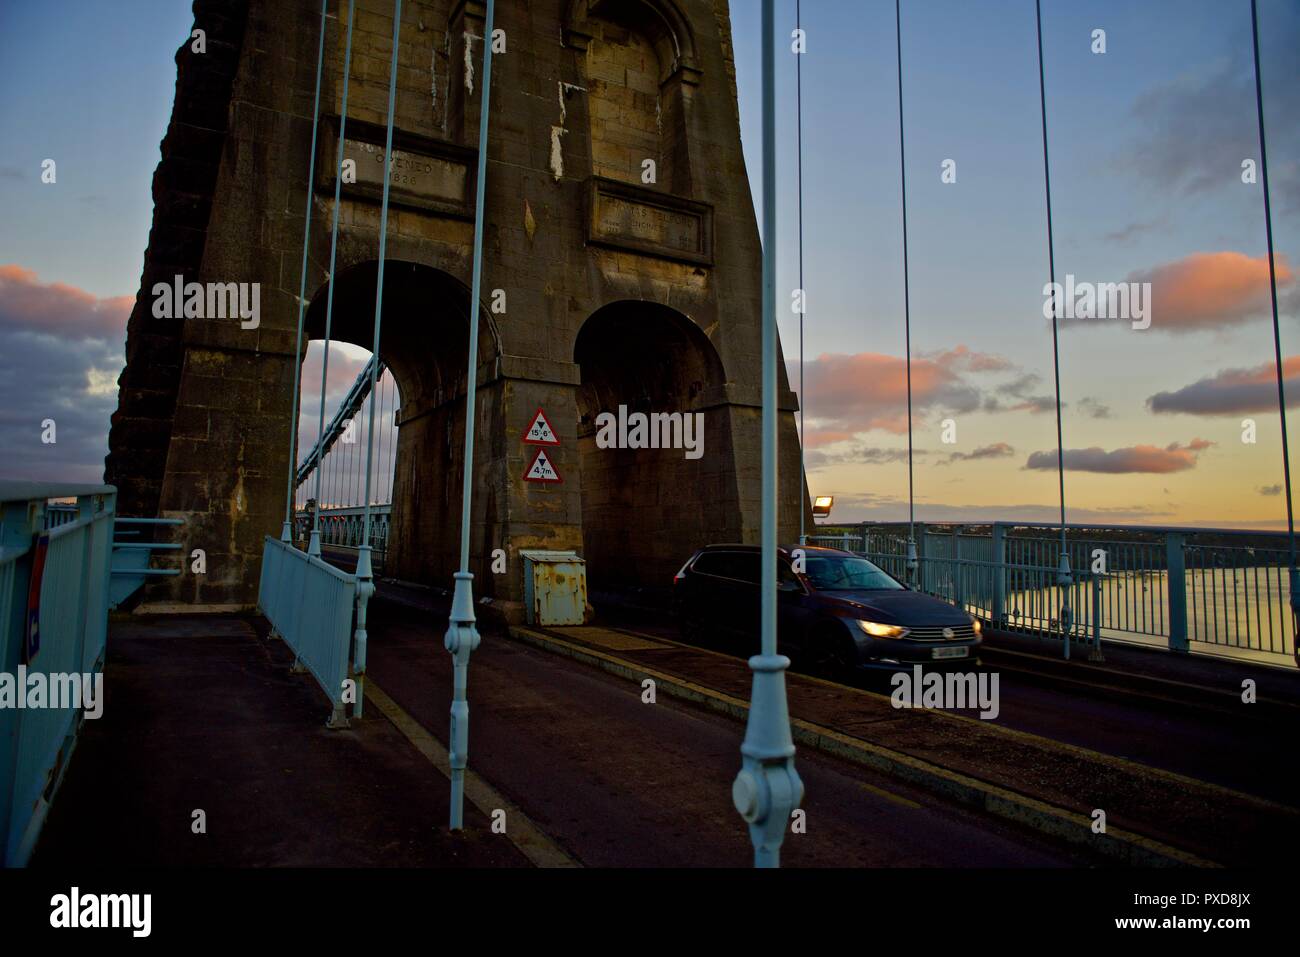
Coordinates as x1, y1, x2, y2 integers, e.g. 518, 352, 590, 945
672, 545, 980, 668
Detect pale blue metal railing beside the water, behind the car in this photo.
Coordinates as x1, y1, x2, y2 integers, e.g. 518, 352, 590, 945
809, 521, 1296, 666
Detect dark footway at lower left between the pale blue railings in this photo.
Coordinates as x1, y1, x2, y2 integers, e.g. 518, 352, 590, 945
33, 615, 528, 869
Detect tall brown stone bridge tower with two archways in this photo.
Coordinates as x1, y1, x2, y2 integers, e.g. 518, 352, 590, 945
107, 0, 807, 618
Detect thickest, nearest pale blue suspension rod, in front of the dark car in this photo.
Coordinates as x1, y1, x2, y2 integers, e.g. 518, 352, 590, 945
732, 0, 803, 867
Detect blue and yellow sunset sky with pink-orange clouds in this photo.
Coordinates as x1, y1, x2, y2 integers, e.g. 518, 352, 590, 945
0, 0, 1300, 527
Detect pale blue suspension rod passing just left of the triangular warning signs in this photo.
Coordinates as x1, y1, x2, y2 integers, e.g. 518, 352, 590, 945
442, 0, 495, 831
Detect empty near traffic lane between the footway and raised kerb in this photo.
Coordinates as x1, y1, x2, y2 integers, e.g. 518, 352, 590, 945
369, 602, 1096, 867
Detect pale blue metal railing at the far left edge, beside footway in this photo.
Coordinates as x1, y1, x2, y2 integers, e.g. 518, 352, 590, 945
0, 481, 117, 866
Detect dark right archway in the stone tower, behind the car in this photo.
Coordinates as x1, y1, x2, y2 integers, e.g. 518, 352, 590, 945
573, 302, 740, 592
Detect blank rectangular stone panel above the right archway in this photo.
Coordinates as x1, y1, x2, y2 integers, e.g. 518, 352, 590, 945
588, 178, 712, 264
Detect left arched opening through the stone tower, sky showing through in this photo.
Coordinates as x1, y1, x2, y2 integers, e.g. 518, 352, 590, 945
299, 260, 499, 584
